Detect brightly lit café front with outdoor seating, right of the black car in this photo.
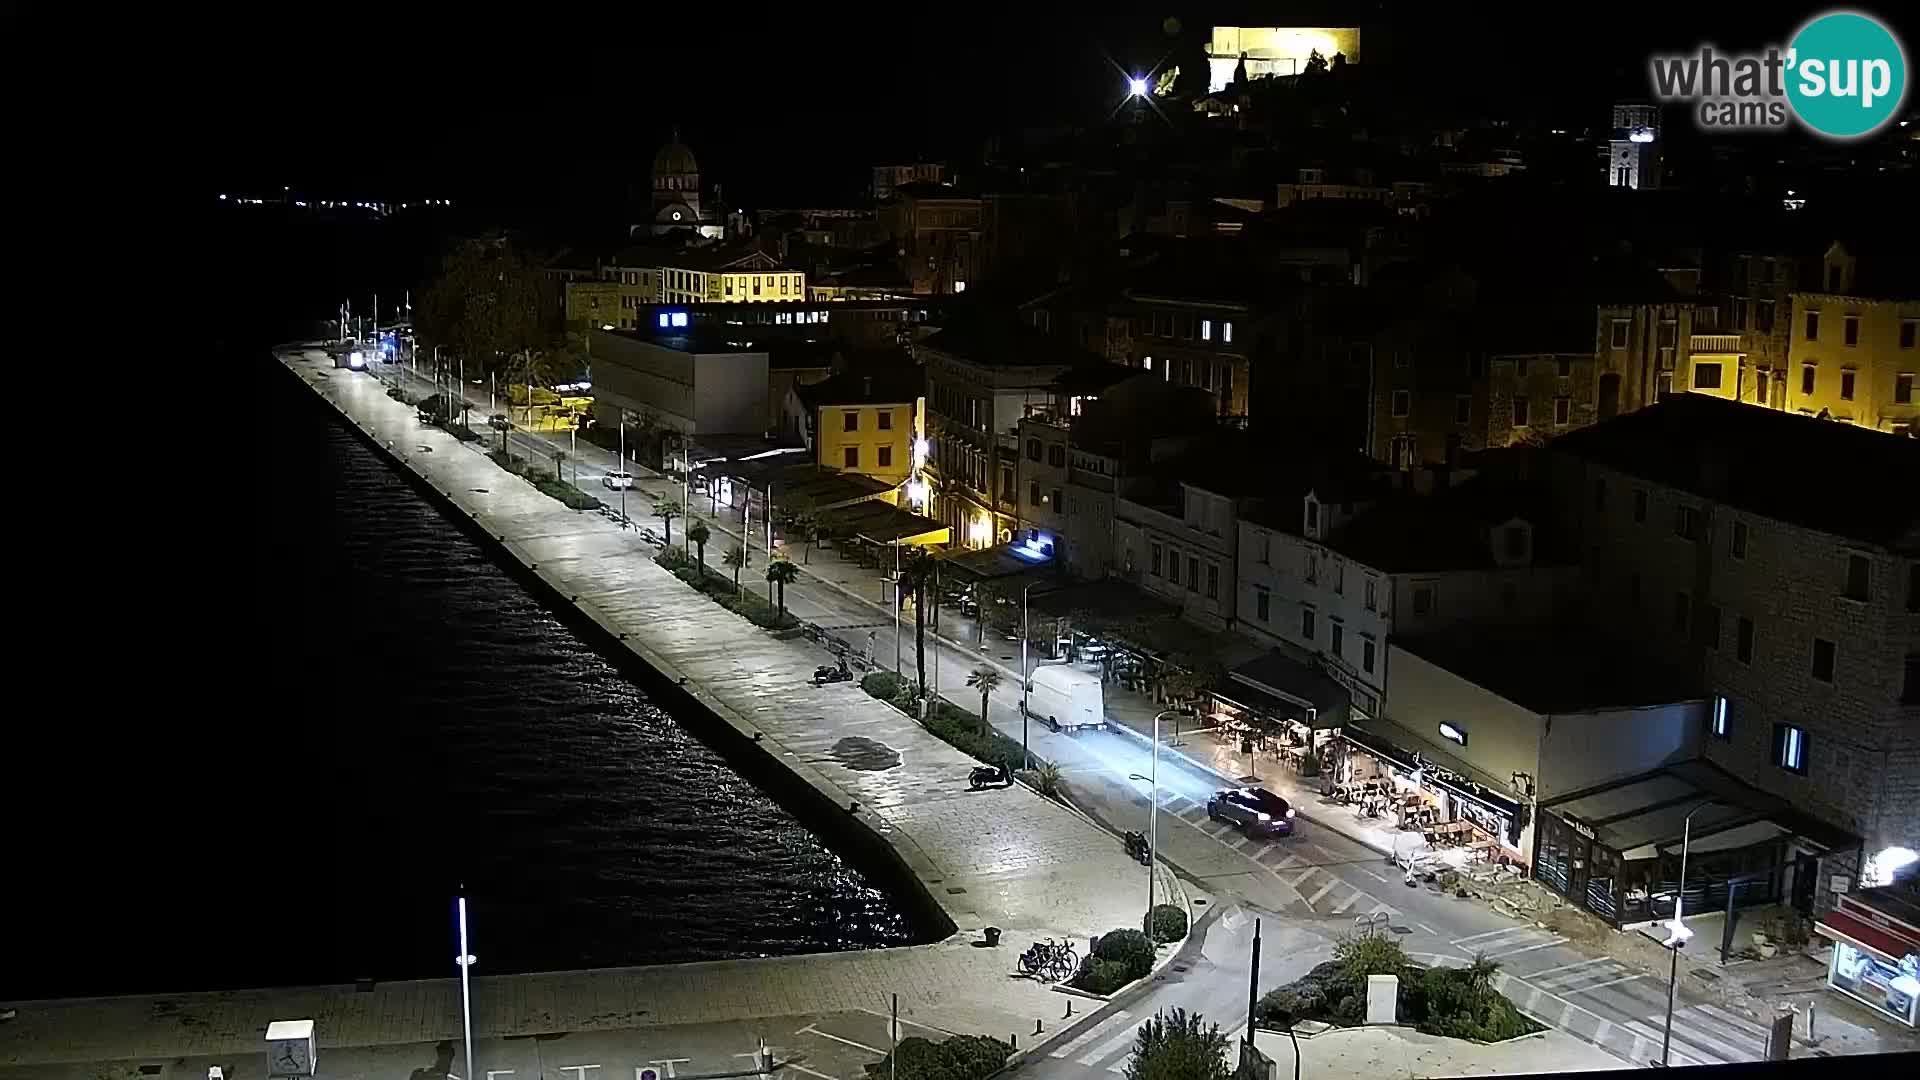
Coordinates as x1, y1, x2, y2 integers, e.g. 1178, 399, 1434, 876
1329, 723, 1528, 865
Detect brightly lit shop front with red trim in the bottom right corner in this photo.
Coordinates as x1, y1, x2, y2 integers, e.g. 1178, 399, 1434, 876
1814, 886, 1920, 1028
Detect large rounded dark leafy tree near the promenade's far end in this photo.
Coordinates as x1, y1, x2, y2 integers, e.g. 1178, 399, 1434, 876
415, 236, 549, 386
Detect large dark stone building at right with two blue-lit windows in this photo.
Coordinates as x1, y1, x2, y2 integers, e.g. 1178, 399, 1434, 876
1553, 394, 1920, 903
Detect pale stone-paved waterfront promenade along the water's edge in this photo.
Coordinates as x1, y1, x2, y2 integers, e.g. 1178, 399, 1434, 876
0, 352, 1183, 1076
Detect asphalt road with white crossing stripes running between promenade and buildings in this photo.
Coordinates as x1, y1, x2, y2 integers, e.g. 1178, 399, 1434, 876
366, 357, 1766, 1065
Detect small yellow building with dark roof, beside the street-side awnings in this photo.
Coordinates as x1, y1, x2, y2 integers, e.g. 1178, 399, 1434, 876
789, 357, 927, 495
